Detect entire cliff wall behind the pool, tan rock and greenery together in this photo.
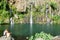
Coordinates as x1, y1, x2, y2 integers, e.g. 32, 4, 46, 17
0, 0, 60, 24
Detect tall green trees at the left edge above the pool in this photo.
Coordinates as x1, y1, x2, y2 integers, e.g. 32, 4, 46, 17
0, 0, 9, 23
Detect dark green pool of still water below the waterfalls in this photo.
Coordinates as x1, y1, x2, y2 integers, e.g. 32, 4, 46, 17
0, 24, 60, 40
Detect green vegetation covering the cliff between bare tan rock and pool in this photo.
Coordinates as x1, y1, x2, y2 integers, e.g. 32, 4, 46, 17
0, 0, 60, 24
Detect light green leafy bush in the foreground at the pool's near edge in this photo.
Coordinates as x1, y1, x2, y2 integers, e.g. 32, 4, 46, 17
29, 32, 53, 40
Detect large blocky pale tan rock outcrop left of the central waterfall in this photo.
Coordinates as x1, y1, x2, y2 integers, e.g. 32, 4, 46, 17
15, 0, 26, 11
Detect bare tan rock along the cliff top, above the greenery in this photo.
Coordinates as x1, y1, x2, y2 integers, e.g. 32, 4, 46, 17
8, 0, 60, 12
